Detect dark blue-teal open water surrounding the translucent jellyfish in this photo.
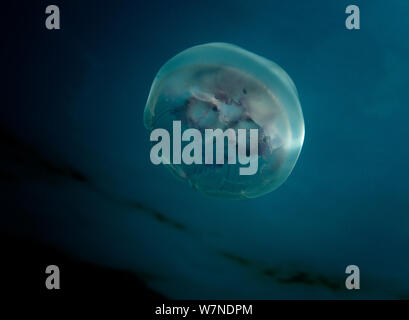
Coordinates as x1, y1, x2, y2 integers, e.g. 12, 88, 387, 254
0, 0, 409, 299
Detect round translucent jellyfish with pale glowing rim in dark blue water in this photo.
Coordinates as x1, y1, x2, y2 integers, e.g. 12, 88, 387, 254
144, 43, 304, 199
